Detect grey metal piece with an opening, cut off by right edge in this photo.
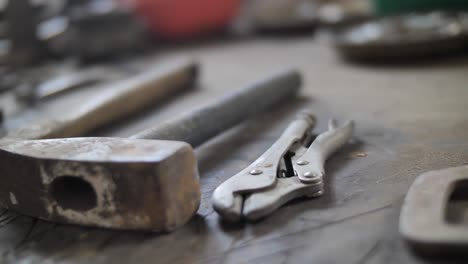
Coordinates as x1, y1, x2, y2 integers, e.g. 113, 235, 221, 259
400, 166, 468, 255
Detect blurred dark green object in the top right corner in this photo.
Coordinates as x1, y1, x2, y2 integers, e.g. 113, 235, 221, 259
372, 0, 468, 15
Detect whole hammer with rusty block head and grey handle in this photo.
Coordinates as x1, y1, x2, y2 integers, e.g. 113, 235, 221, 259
0, 70, 301, 232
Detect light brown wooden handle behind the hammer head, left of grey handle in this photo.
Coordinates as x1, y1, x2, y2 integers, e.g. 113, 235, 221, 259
6, 60, 198, 139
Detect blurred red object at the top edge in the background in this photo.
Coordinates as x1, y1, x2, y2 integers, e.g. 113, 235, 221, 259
134, 0, 240, 39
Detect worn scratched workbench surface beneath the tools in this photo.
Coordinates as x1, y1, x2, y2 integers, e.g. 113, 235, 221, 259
0, 37, 468, 264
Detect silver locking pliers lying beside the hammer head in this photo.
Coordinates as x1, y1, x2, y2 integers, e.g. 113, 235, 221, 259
213, 113, 354, 221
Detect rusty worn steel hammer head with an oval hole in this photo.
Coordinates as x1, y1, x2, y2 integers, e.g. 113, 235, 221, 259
0, 138, 200, 231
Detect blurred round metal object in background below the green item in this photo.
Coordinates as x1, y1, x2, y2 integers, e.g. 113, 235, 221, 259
335, 12, 468, 61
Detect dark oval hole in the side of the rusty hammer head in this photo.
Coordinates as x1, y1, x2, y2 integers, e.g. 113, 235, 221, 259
50, 176, 97, 211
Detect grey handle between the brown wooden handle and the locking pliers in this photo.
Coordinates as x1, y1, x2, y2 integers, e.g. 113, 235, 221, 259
131, 70, 301, 147
